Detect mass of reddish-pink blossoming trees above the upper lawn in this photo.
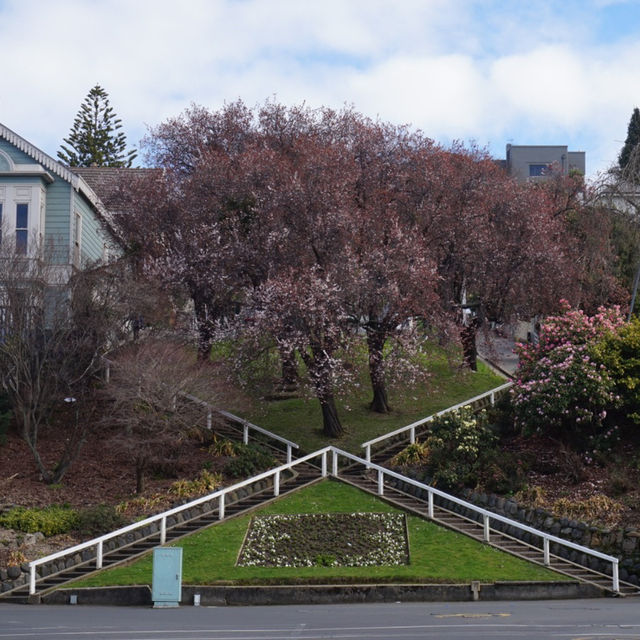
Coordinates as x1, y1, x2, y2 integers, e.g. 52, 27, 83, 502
116, 102, 620, 436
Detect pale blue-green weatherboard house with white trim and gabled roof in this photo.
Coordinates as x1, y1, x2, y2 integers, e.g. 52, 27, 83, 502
0, 124, 120, 275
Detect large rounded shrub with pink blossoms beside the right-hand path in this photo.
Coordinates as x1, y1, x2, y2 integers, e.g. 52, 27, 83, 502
512, 301, 625, 447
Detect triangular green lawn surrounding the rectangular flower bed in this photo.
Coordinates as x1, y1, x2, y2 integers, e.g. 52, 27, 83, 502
75, 480, 566, 586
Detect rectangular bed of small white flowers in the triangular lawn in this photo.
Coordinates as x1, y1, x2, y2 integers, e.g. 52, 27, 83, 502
238, 513, 409, 567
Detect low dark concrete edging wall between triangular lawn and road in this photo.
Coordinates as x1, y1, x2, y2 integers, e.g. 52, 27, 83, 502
40, 581, 604, 607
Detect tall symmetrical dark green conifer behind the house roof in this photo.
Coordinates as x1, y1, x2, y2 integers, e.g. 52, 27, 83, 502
58, 84, 137, 167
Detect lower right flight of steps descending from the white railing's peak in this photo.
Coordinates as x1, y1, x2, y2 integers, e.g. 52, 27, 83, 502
340, 463, 640, 596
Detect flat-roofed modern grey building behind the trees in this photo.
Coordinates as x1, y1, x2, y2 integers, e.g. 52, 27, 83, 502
506, 144, 585, 180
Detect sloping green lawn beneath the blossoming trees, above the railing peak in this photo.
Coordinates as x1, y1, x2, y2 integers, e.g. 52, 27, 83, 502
246, 360, 505, 455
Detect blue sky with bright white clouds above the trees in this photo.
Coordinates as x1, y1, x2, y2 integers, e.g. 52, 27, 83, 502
0, 0, 640, 177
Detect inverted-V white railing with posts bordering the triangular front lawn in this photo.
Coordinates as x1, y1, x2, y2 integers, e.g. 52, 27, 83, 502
29, 447, 620, 595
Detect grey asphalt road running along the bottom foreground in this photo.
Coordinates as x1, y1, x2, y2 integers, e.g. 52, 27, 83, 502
0, 598, 640, 640
